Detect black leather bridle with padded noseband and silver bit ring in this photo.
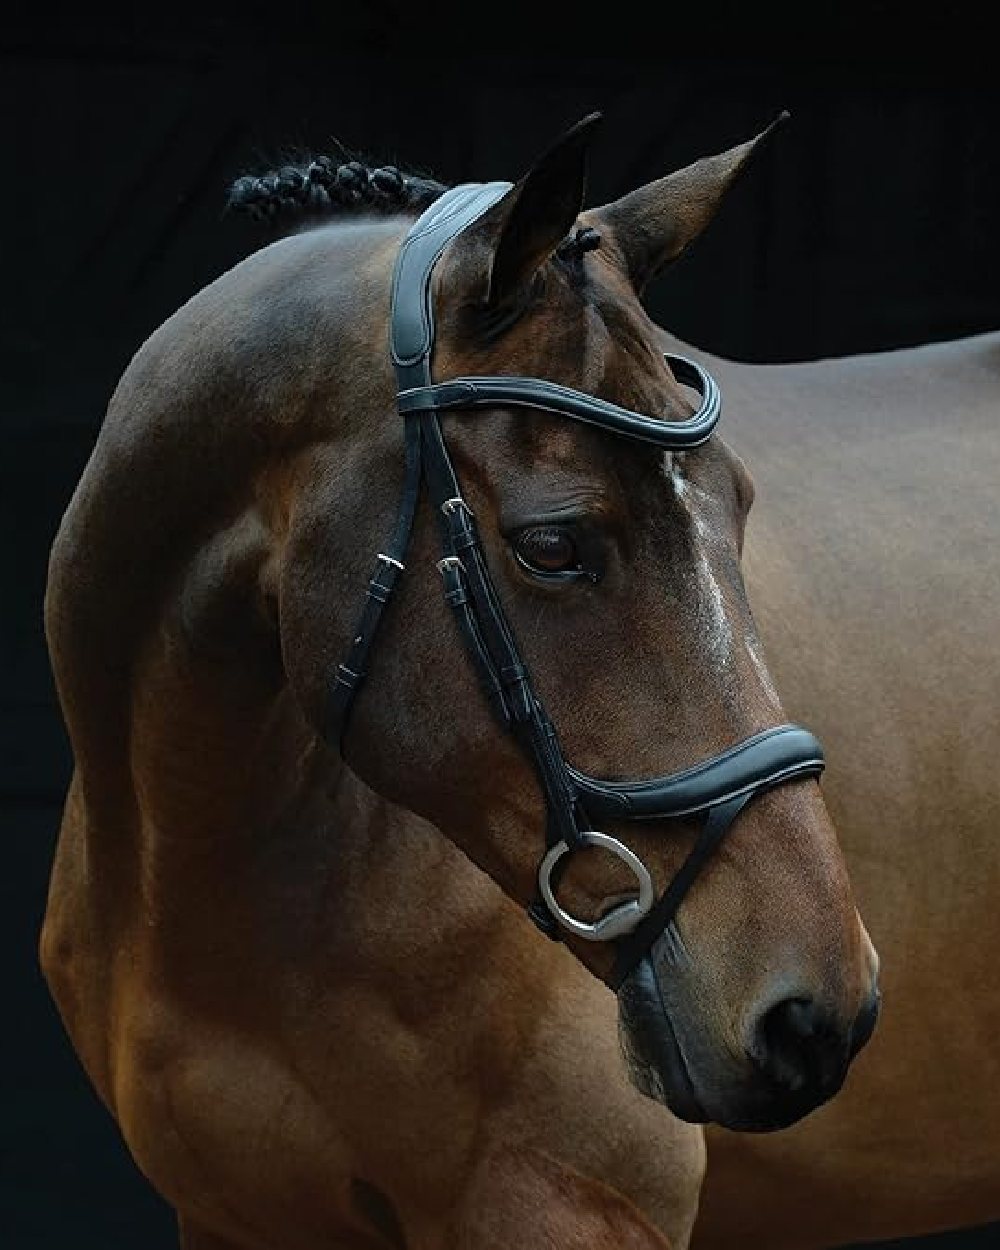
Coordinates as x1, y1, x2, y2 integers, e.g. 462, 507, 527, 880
325, 183, 824, 989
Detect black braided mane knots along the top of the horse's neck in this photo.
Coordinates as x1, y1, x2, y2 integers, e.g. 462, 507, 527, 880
226, 156, 446, 229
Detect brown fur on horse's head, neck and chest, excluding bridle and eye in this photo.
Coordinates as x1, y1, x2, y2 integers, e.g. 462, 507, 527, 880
41, 119, 874, 1250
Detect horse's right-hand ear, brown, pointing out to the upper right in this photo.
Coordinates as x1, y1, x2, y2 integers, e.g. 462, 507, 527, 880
588, 111, 789, 293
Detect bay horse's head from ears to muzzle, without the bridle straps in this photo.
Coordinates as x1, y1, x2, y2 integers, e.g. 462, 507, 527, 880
255, 119, 878, 1129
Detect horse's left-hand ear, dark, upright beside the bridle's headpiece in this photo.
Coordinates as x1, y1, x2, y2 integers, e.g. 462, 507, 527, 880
469, 113, 601, 311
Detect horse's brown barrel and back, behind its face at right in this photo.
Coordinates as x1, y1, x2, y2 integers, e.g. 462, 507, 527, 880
645, 330, 1000, 1250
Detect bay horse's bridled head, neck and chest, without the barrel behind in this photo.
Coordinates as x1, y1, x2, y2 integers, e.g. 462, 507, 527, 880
40, 118, 878, 1250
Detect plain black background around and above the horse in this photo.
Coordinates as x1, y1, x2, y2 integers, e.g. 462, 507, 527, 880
0, 4, 1000, 1250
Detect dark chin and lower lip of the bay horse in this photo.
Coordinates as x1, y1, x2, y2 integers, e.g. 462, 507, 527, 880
618, 958, 818, 1133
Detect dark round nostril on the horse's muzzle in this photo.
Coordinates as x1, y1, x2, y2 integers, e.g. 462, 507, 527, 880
749, 999, 850, 1099
